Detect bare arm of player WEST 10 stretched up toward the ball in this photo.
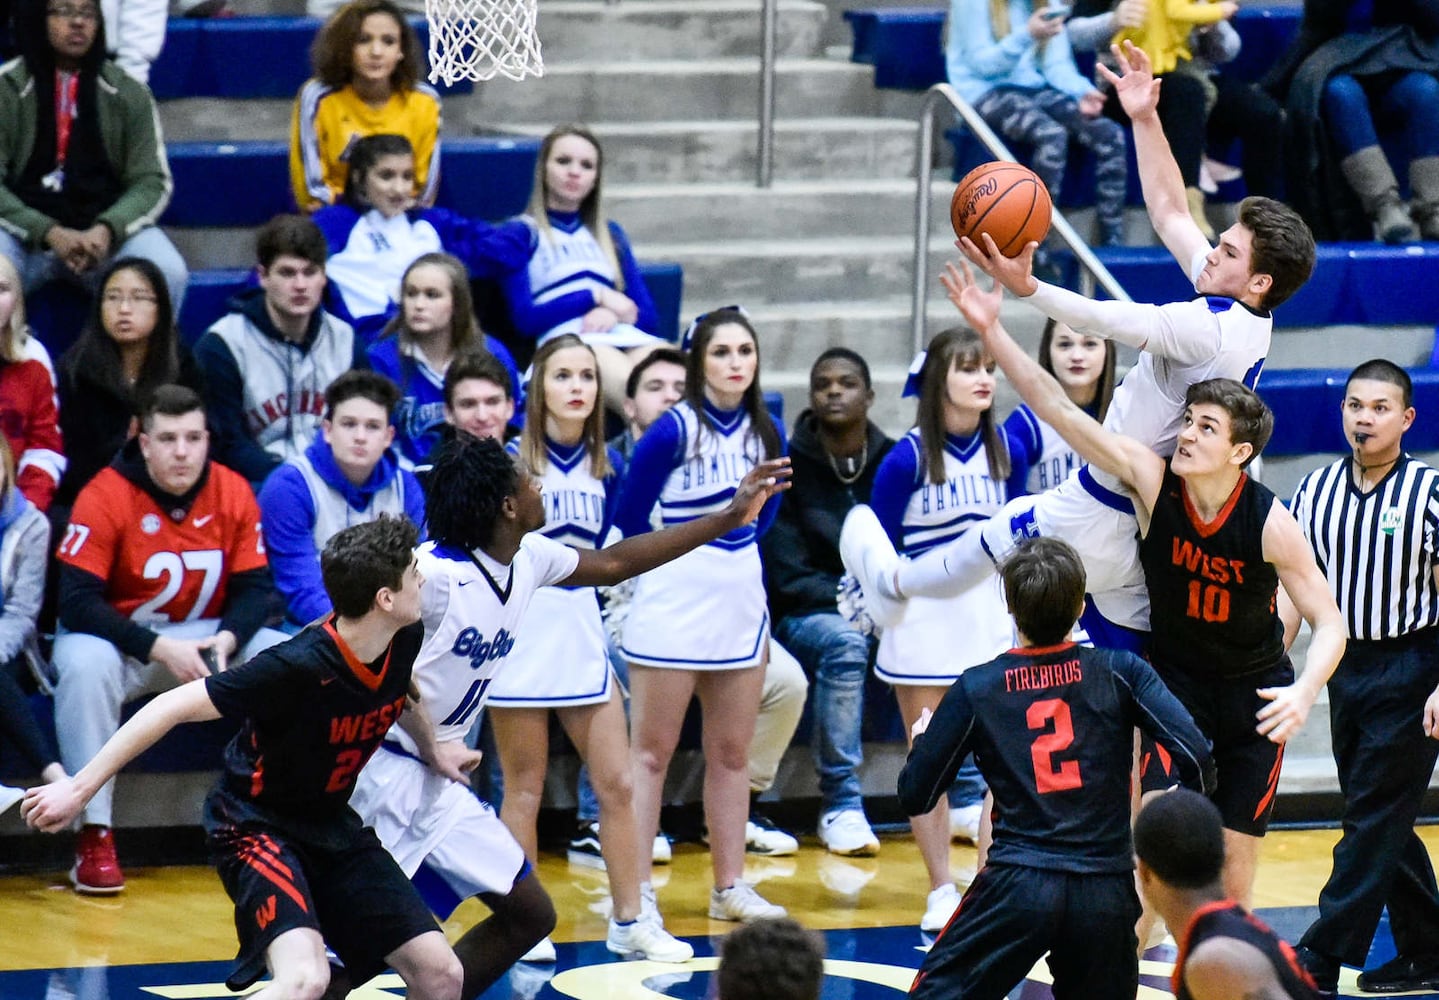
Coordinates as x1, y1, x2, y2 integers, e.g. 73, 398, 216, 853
940, 262, 1164, 515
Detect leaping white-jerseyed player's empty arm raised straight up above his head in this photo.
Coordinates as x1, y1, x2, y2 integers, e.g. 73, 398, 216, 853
1098, 39, 1209, 266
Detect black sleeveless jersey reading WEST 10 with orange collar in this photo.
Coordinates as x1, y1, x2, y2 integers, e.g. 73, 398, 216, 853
1140, 469, 1284, 678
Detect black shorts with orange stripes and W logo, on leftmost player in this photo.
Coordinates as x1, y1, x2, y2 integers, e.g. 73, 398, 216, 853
209, 823, 437, 990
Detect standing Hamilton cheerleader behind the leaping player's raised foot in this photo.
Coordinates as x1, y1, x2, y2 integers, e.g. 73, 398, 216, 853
869, 327, 1013, 932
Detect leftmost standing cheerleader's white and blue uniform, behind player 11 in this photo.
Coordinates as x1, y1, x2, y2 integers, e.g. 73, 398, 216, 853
489, 439, 620, 708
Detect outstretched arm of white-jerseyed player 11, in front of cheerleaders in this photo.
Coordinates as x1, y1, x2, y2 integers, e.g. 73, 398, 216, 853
560, 458, 790, 587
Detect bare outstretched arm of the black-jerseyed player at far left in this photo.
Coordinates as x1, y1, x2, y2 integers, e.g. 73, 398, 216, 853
20, 679, 220, 833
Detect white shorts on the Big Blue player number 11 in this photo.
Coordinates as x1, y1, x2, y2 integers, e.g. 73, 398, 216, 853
350, 742, 528, 919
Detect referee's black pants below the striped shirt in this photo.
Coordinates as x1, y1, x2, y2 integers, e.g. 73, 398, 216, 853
1299, 629, 1439, 965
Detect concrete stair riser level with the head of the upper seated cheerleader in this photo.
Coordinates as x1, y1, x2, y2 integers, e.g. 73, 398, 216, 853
501, 118, 917, 187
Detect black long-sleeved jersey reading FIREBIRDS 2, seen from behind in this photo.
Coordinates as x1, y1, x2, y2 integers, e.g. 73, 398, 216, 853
898, 643, 1215, 873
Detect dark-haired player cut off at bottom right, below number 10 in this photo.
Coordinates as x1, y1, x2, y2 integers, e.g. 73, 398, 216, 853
1134, 788, 1320, 1000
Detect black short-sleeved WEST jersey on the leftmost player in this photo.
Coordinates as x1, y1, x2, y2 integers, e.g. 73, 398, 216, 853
206, 622, 425, 847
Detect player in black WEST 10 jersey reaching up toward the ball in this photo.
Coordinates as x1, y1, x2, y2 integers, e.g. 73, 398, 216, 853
943, 265, 1345, 905
